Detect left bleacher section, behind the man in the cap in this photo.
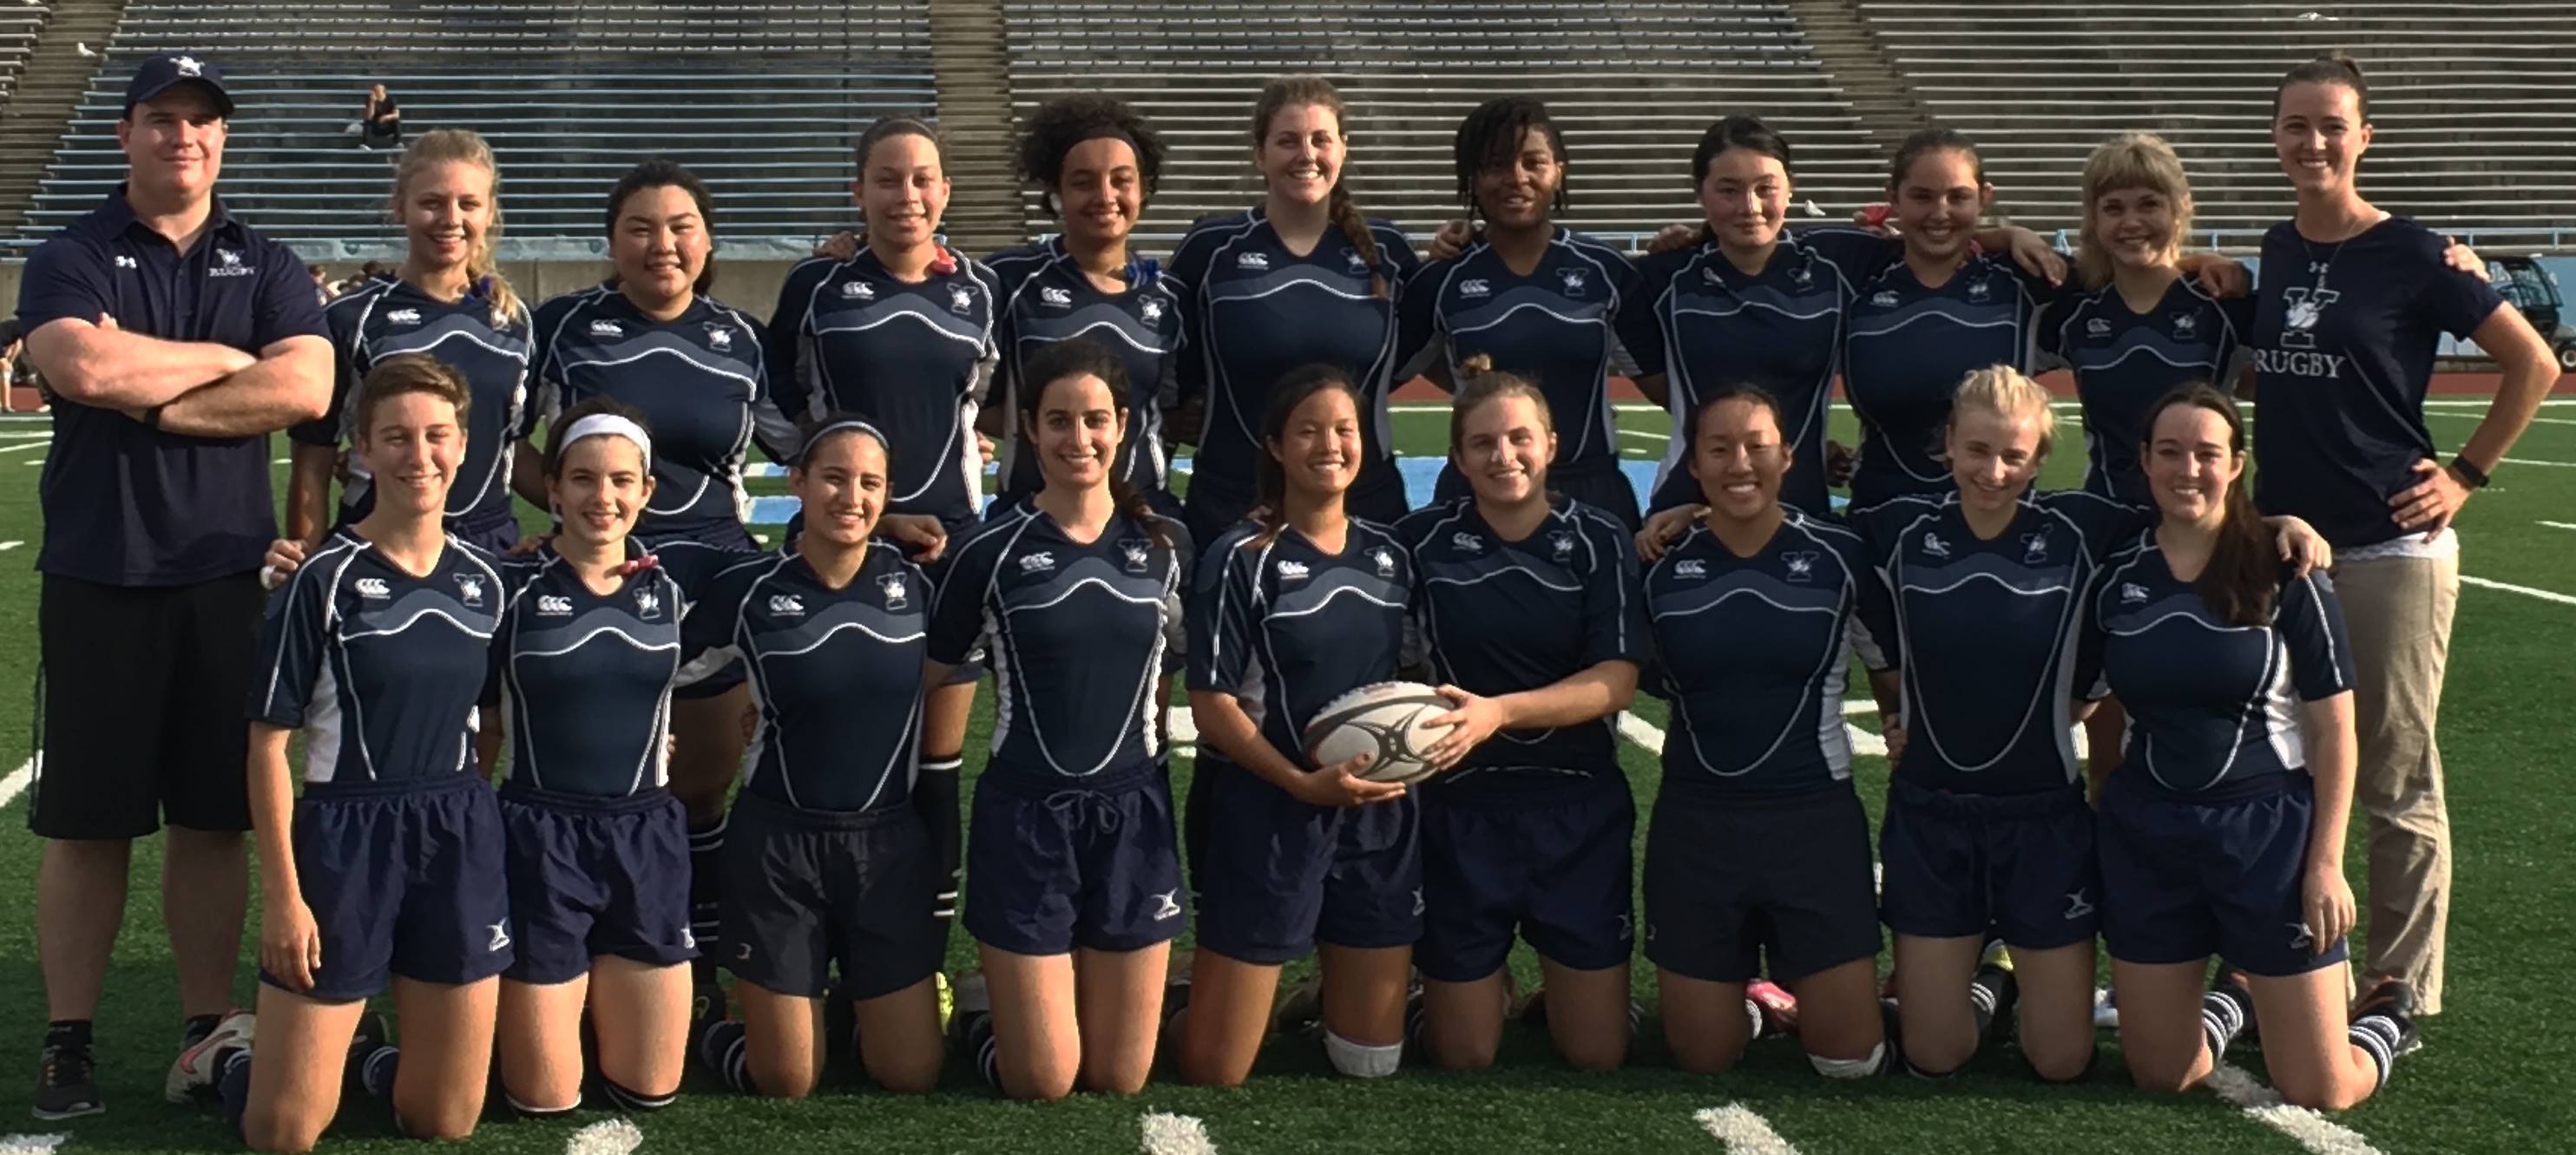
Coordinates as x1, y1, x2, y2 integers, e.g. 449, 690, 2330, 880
21, 0, 932, 255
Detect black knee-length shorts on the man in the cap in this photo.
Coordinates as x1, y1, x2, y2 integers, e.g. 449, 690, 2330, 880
26, 573, 268, 838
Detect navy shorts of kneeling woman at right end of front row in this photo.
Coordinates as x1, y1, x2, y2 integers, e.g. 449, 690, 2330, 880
2102, 765, 2344, 977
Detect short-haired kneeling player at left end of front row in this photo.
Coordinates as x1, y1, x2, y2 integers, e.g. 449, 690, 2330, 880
208, 356, 513, 1152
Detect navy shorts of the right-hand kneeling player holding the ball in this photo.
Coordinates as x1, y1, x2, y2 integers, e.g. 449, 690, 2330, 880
1414, 771, 1636, 982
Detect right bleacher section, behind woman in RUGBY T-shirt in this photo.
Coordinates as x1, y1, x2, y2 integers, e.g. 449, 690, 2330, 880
1860, 0, 2576, 247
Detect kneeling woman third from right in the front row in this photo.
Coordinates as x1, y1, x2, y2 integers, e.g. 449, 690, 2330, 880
1644, 387, 1896, 1078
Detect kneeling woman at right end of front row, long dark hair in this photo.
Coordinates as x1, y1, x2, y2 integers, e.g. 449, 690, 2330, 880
2086, 387, 2414, 1111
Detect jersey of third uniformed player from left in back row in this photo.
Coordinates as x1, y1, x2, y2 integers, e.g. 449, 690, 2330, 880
767, 247, 1002, 523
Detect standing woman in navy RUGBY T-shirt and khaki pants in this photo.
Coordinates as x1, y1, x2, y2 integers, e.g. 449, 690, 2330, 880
2249, 56, 2558, 1041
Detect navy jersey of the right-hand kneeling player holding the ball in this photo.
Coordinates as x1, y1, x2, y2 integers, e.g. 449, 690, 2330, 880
1396, 497, 1651, 797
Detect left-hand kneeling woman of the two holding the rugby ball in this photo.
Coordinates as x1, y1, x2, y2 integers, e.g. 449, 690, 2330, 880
1172, 366, 1422, 1086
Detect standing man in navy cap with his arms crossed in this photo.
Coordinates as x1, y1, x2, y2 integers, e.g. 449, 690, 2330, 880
18, 54, 332, 1119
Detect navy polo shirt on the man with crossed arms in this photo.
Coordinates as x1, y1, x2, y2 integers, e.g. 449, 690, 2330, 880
18, 186, 330, 585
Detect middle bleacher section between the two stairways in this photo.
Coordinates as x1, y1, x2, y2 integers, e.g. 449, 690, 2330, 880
1002, 0, 1881, 240
